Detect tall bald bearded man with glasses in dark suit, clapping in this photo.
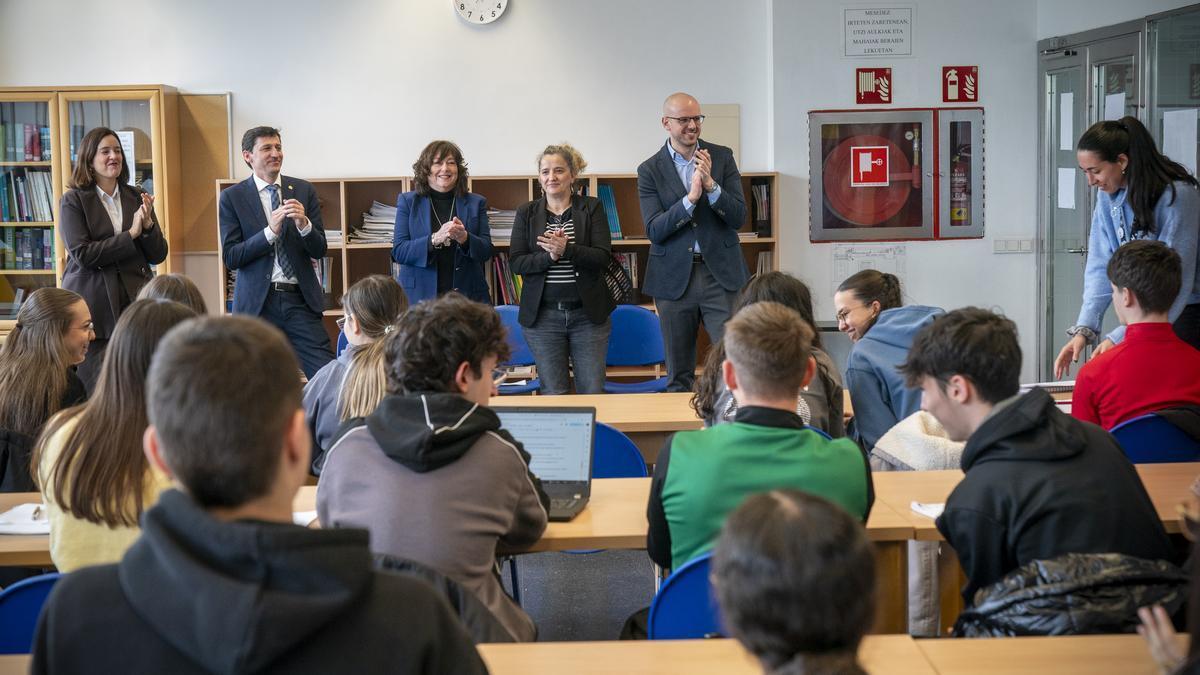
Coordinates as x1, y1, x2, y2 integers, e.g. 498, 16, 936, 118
637, 92, 748, 392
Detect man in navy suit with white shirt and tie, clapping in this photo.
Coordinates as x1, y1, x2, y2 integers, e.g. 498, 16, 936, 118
220, 126, 334, 377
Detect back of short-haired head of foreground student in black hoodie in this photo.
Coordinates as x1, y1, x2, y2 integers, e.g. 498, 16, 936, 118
149, 316, 301, 508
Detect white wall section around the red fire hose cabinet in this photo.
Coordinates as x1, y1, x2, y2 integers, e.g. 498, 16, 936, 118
773, 0, 1037, 381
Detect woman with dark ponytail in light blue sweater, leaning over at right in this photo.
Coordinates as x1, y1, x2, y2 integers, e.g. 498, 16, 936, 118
1055, 117, 1200, 377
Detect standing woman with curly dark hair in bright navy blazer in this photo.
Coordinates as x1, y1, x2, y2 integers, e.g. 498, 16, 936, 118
391, 141, 492, 304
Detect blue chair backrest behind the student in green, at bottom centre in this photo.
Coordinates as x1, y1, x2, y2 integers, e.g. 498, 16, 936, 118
647, 552, 722, 640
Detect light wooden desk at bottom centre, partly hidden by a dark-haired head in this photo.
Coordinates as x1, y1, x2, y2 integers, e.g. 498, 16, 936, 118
479, 635, 936, 675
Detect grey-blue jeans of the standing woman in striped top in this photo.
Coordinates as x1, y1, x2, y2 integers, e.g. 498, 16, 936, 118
524, 306, 612, 394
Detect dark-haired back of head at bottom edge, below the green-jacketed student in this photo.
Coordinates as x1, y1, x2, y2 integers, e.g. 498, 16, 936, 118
713, 490, 875, 673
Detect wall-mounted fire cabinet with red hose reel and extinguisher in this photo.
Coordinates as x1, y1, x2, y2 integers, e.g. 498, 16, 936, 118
809, 108, 983, 241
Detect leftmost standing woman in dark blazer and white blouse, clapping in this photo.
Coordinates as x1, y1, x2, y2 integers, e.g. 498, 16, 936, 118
59, 127, 167, 392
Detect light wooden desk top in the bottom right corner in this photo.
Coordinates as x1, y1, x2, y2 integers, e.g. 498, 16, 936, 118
917, 635, 1187, 675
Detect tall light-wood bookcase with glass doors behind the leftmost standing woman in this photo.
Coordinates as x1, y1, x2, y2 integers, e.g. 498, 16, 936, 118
0, 84, 182, 331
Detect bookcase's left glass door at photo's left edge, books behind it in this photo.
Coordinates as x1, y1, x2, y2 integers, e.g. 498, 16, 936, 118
0, 91, 60, 319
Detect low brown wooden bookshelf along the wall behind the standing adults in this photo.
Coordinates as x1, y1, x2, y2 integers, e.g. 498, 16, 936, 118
216, 172, 779, 357
